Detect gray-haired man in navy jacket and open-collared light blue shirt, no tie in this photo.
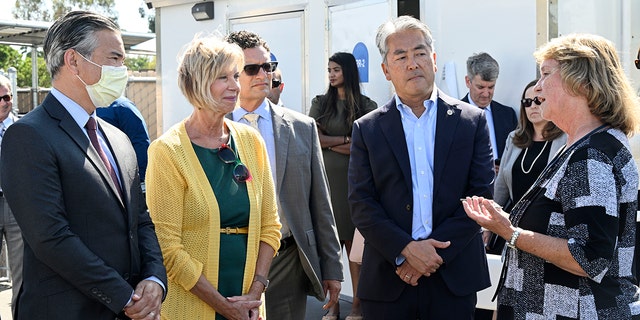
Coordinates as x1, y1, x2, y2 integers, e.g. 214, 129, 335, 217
348, 16, 494, 320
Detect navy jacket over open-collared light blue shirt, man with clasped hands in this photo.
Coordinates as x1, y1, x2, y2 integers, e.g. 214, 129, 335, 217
349, 91, 494, 301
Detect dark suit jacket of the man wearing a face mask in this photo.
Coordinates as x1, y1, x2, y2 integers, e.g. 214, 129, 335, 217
0, 94, 167, 320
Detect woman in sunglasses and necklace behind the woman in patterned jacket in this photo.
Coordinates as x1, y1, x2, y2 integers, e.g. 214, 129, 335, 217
483, 80, 567, 254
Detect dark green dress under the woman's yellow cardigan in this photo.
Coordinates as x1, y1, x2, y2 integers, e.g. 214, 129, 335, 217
193, 139, 249, 320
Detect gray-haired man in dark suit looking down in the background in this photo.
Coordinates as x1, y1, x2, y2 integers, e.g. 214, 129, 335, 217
462, 52, 518, 174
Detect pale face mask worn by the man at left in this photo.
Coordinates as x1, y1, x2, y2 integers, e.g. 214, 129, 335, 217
76, 52, 129, 108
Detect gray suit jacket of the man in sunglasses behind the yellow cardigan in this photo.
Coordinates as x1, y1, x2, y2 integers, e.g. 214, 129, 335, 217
268, 102, 343, 300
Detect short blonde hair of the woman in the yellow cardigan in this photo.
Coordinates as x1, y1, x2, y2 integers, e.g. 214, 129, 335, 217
178, 35, 244, 109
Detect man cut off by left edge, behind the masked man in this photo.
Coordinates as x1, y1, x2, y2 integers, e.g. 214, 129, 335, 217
0, 75, 24, 314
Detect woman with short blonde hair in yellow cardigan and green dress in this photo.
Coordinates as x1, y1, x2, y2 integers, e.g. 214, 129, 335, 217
146, 37, 280, 320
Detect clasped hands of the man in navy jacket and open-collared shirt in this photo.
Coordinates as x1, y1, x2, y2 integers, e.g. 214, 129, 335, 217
396, 239, 451, 286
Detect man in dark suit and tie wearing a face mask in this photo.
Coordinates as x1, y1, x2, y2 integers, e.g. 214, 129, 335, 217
0, 11, 167, 320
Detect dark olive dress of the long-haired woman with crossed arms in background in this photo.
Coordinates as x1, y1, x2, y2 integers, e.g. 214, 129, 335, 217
309, 96, 378, 241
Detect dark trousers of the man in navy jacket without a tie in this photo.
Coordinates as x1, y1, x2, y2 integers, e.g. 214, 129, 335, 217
360, 273, 477, 320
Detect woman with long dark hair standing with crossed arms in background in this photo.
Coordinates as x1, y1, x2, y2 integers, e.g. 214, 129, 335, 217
309, 52, 378, 320
